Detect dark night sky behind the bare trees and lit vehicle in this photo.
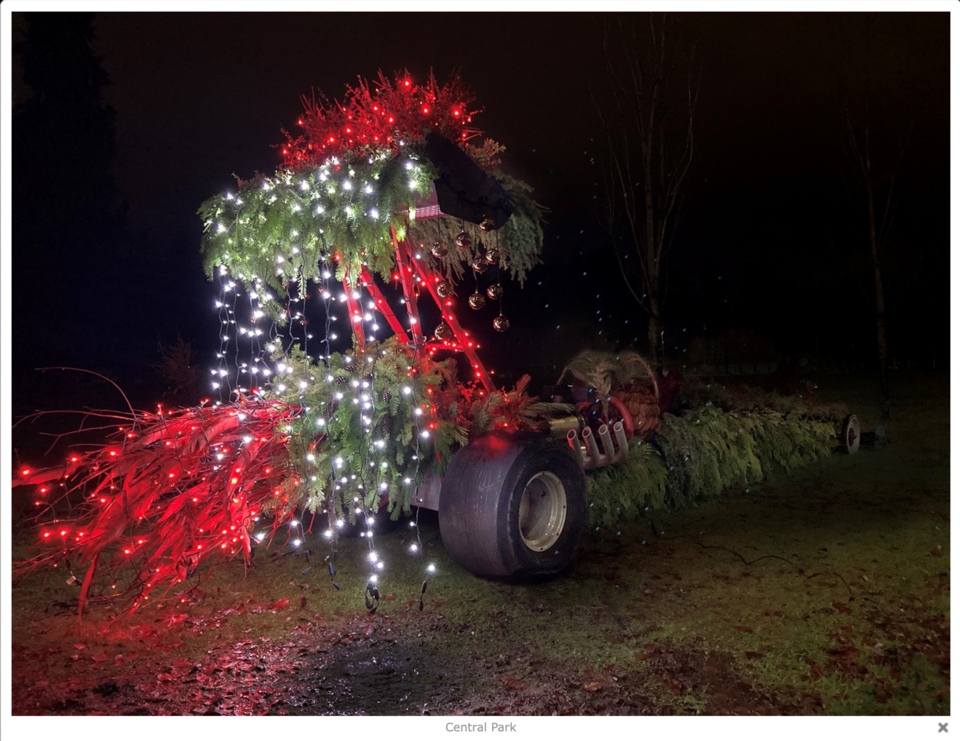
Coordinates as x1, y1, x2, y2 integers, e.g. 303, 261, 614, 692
13, 8, 949, 416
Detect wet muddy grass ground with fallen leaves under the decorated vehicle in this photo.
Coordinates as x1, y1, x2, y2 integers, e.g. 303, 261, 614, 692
12, 375, 950, 715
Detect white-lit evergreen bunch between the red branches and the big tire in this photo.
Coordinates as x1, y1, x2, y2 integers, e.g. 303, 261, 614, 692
265, 338, 466, 521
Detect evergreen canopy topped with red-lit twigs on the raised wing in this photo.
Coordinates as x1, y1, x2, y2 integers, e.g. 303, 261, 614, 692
199, 75, 543, 293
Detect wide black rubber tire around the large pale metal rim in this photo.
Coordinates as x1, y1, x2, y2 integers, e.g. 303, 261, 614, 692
439, 433, 587, 577
